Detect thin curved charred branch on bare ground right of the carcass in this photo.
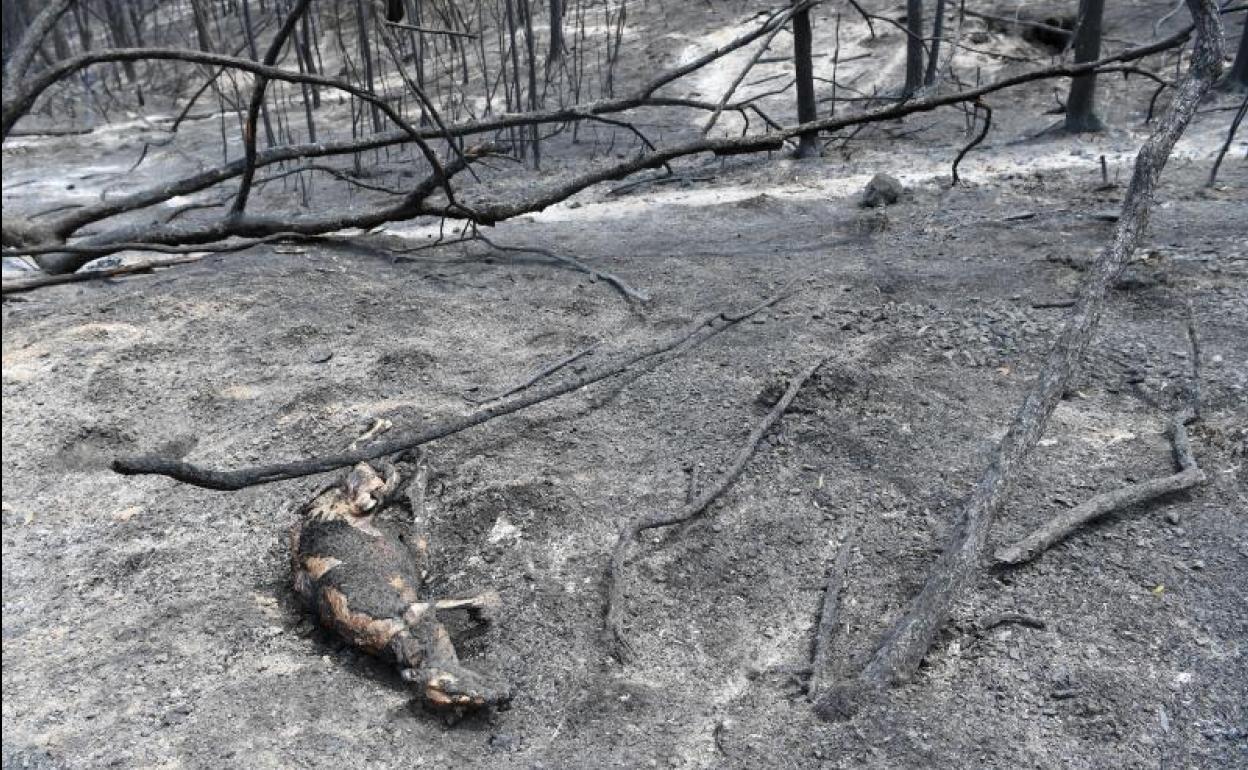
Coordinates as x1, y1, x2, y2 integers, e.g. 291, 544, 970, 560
605, 357, 827, 661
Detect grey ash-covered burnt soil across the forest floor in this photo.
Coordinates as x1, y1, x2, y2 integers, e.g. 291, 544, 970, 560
2, 4, 1248, 768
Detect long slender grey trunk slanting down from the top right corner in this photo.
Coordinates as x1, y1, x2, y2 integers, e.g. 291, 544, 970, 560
816, 0, 1222, 719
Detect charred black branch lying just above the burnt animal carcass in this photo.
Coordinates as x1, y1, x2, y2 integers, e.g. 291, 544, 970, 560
112, 292, 790, 490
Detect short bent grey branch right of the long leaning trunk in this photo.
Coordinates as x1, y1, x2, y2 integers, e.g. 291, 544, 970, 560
993, 409, 1206, 567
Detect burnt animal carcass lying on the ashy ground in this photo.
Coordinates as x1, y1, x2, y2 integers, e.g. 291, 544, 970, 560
292, 463, 510, 711
